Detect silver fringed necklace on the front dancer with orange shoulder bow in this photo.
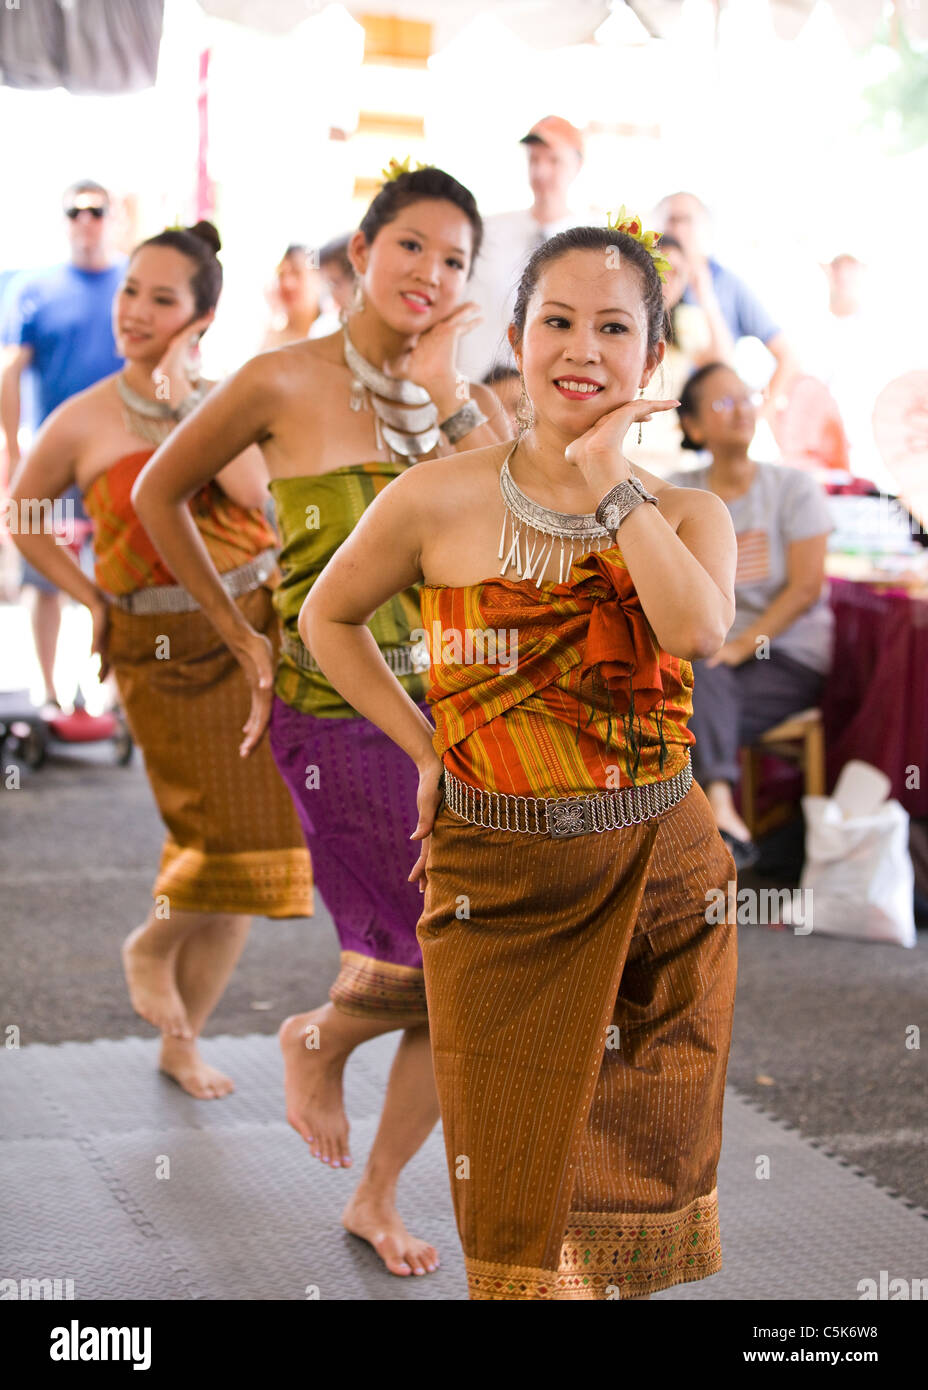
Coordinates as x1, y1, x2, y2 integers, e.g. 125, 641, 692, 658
499, 439, 615, 588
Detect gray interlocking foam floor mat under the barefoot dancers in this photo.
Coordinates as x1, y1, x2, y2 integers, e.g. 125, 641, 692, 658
0, 1036, 928, 1301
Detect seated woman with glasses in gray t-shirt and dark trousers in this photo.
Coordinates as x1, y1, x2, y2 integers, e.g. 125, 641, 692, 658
668, 363, 834, 869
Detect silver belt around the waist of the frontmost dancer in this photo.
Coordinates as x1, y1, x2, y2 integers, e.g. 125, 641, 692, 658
445, 756, 693, 840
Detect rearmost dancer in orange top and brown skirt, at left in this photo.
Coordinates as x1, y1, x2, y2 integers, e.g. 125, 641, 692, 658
14, 222, 313, 1099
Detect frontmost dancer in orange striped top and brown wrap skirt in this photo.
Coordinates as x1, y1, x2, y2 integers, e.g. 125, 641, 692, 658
300, 214, 736, 1300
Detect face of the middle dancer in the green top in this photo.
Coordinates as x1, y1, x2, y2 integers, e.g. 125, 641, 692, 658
349, 199, 474, 335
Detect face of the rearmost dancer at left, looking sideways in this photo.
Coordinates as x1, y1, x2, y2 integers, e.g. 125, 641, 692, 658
113, 246, 205, 361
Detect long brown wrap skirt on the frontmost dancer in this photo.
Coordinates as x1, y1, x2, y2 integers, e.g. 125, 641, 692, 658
418, 784, 736, 1300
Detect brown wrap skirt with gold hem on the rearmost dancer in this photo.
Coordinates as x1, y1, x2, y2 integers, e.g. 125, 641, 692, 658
108, 588, 313, 917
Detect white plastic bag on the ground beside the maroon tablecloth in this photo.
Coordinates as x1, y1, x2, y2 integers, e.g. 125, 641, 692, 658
800, 788, 915, 947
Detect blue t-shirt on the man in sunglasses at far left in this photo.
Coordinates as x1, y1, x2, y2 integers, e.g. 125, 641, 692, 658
0, 259, 126, 427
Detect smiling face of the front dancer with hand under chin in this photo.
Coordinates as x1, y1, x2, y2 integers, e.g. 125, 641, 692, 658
513, 247, 664, 439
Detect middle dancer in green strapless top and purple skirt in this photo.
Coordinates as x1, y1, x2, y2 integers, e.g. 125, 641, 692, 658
135, 168, 508, 1275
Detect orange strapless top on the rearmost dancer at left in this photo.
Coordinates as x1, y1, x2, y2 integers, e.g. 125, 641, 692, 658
83, 449, 276, 595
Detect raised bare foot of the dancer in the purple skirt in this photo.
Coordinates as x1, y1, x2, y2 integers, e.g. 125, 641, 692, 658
278, 1004, 353, 1168
